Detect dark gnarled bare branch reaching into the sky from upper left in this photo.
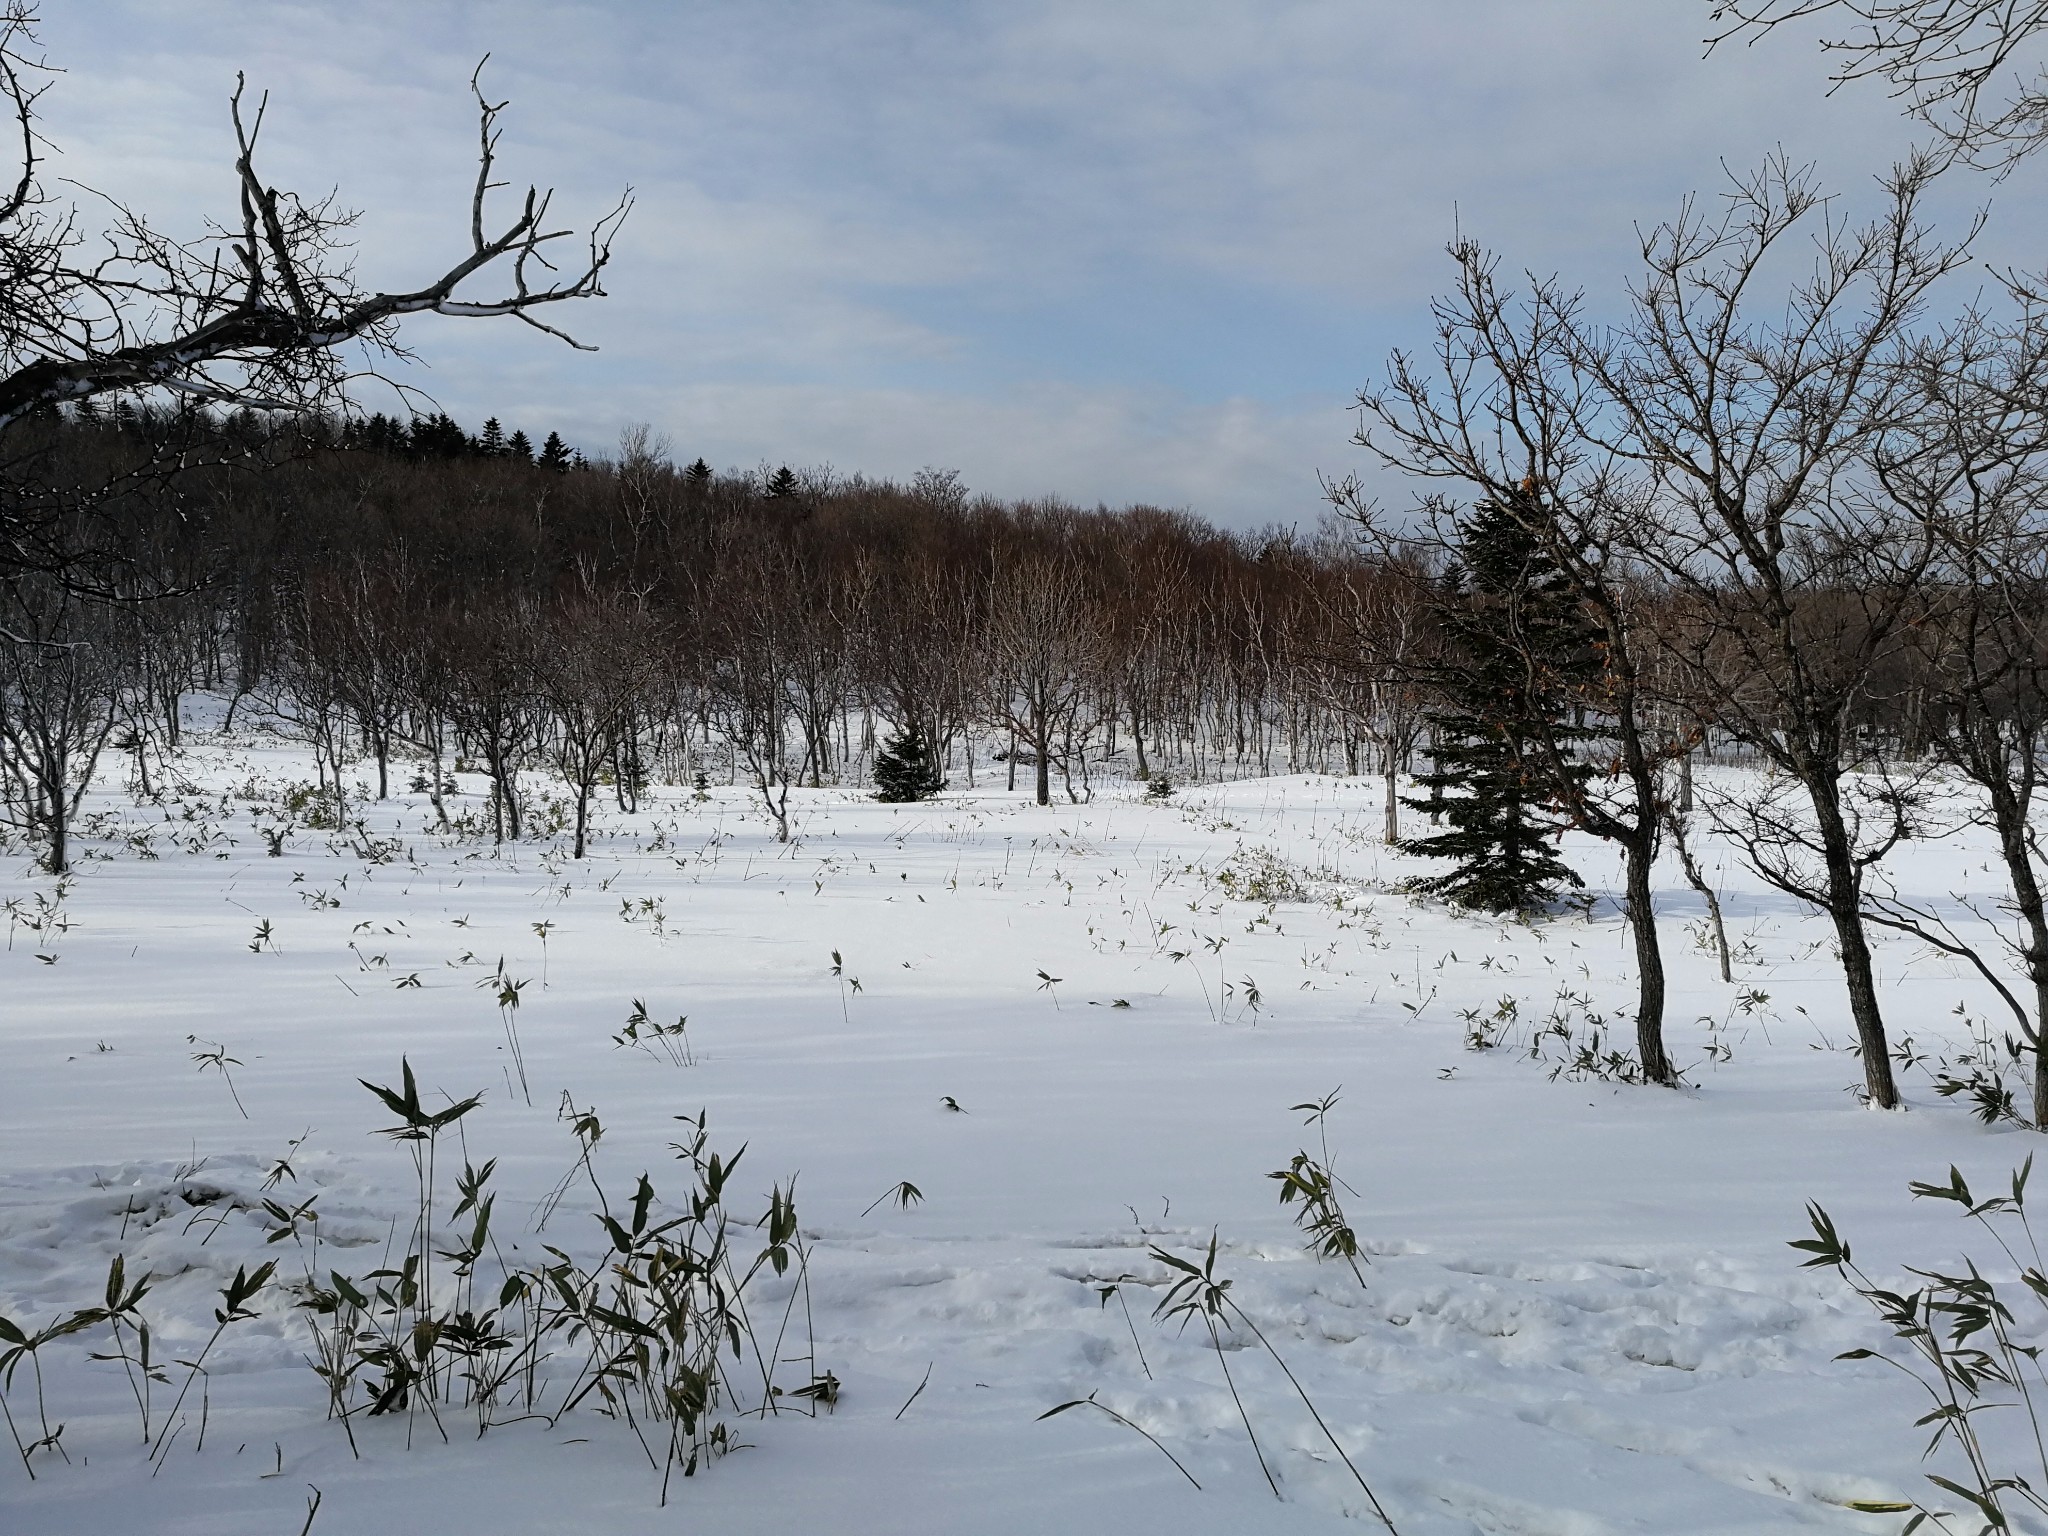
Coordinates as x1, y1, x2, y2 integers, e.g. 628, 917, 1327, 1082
0, 0, 631, 436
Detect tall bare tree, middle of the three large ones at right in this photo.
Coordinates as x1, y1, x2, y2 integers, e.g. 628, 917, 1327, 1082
1559, 158, 1966, 1108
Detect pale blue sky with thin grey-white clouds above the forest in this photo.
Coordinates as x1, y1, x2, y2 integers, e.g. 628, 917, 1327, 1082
41, 0, 2048, 528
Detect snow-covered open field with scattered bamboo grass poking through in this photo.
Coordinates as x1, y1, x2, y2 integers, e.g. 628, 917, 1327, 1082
0, 716, 2034, 1536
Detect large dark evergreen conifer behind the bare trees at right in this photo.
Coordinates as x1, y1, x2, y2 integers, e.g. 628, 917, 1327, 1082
1401, 498, 1595, 913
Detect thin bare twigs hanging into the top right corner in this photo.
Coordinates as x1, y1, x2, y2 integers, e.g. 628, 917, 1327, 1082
1708, 0, 2048, 170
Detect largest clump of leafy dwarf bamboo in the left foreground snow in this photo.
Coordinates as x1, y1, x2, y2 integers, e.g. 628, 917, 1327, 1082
301, 1063, 819, 1501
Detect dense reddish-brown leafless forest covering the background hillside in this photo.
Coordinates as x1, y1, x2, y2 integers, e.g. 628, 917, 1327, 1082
0, 412, 1441, 854
